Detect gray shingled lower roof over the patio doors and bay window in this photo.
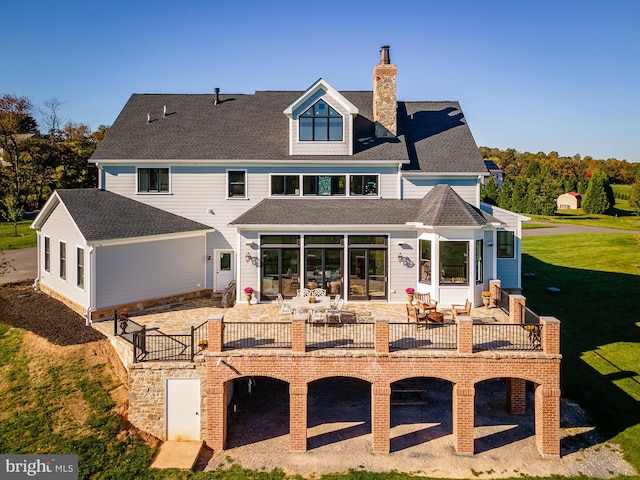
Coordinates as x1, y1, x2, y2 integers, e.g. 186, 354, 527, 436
231, 184, 502, 227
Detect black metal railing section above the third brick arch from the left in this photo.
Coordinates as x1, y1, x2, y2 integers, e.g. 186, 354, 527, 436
389, 323, 458, 352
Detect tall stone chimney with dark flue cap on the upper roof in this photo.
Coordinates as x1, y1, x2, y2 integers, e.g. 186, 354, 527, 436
373, 45, 398, 138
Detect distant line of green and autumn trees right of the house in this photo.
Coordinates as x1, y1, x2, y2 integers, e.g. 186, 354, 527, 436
480, 147, 640, 215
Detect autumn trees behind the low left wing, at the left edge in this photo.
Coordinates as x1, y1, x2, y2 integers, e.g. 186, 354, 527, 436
0, 94, 108, 229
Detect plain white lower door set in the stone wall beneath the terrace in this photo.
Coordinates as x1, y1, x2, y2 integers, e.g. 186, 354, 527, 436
165, 378, 200, 441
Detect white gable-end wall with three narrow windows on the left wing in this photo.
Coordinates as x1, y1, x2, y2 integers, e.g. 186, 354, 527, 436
38, 204, 90, 308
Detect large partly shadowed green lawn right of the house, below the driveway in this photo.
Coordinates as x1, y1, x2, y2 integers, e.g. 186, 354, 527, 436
522, 234, 640, 471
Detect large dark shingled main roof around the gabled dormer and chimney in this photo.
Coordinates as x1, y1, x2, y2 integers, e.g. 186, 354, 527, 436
92, 91, 486, 172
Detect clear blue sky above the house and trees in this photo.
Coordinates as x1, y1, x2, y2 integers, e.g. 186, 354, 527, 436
5, 0, 640, 162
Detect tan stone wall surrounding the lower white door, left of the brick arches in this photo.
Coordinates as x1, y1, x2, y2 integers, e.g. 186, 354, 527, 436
129, 357, 207, 440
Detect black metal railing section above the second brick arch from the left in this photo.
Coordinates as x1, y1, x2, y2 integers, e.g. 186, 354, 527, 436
306, 322, 375, 350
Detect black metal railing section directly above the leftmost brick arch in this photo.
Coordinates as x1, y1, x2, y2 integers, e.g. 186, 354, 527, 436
222, 322, 291, 350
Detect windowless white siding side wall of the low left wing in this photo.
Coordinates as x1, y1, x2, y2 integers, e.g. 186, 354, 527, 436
94, 235, 207, 309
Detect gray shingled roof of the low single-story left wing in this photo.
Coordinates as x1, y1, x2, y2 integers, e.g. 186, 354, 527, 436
56, 189, 211, 242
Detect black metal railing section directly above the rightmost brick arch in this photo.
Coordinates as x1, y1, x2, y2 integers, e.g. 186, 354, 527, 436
473, 323, 542, 352
